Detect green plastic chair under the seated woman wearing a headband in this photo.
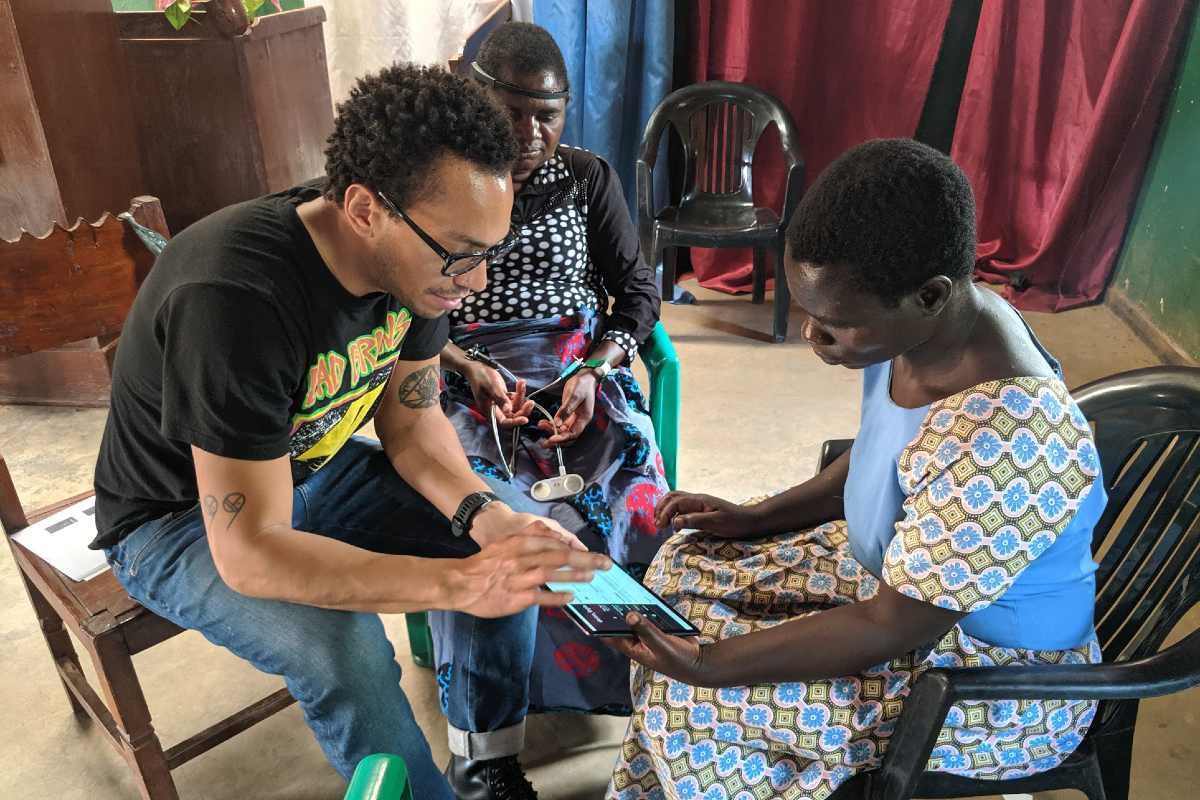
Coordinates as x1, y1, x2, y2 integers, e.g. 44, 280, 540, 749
406, 323, 679, 668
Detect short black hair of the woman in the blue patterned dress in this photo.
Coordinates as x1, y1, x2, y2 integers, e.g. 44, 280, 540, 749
787, 139, 976, 307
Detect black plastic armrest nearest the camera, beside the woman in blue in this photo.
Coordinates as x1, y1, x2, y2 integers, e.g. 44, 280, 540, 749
870, 631, 1200, 800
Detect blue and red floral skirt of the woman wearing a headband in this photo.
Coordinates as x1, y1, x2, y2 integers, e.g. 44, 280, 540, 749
430, 313, 668, 714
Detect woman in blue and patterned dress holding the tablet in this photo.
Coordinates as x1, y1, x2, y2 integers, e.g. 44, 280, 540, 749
608, 139, 1105, 800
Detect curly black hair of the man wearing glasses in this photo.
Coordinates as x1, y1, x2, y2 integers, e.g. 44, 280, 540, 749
325, 64, 517, 207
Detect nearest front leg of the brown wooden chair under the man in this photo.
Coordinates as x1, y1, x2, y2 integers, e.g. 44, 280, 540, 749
90, 631, 179, 800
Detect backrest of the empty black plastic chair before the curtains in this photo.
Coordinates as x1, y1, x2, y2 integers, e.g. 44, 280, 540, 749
642, 80, 803, 207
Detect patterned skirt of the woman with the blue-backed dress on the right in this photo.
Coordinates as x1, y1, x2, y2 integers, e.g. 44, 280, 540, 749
606, 521, 1100, 800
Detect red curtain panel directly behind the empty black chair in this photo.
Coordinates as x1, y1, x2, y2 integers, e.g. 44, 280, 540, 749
688, 0, 950, 291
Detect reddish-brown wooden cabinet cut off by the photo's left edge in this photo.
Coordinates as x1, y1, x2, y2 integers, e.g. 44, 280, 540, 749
0, 0, 146, 240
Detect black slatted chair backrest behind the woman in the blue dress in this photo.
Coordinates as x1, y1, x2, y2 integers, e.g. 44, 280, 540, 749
1072, 367, 1200, 661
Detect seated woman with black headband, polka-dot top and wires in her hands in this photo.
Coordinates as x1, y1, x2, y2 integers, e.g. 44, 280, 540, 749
433, 23, 667, 714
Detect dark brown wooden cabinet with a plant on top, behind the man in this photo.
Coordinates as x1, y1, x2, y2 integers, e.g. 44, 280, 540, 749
116, 6, 334, 233
